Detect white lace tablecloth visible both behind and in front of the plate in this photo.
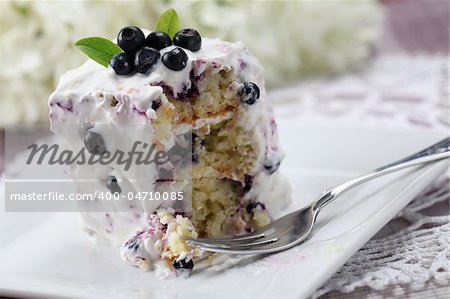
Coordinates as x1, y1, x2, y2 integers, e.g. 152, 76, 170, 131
271, 55, 450, 298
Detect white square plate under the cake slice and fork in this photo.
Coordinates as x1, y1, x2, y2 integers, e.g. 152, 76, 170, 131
0, 122, 448, 298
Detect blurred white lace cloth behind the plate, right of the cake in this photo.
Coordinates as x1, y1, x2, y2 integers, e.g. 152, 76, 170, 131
270, 54, 450, 132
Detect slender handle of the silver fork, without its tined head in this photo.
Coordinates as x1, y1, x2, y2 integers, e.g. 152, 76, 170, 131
313, 137, 450, 212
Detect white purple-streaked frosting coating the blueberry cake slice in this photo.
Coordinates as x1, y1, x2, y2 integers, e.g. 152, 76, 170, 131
49, 31, 290, 268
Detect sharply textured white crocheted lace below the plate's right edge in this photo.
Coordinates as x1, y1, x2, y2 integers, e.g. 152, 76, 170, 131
314, 176, 450, 297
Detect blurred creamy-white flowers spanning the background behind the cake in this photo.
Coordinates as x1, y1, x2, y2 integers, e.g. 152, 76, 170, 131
0, 0, 381, 127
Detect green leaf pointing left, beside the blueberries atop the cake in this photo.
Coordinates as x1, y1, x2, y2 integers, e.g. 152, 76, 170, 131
75, 37, 123, 67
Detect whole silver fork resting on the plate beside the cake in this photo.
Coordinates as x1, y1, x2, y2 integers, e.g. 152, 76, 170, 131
187, 138, 450, 254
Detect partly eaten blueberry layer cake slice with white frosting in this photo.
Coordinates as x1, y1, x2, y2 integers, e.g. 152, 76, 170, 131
49, 22, 290, 273
